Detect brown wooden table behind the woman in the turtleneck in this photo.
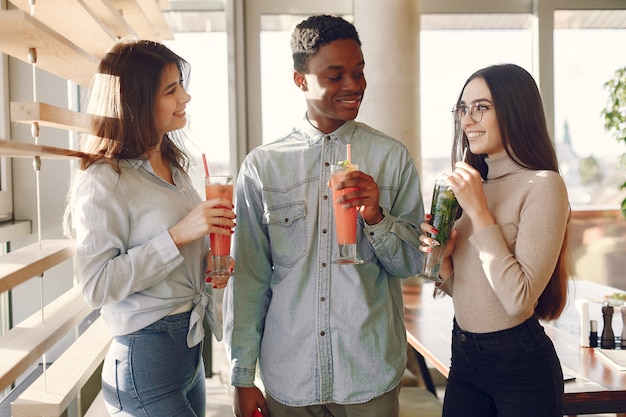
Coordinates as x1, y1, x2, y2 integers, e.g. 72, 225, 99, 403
403, 280, 626, 417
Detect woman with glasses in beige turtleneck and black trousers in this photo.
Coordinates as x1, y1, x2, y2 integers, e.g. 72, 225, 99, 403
421, 64, 569, 417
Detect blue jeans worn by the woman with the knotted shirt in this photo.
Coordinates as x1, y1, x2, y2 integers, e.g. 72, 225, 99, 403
102, 312, 206, 417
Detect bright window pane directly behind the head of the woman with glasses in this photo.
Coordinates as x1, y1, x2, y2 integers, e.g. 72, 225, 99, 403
420, 15, 532, 204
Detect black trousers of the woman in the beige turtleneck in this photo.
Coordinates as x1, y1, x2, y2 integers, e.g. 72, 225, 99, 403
443, 317, 563, 417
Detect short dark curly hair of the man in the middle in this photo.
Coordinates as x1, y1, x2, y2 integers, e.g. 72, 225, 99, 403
291, 15, 361, 72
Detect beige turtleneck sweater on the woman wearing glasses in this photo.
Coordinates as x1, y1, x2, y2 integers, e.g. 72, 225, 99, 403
441, 154, 569, 333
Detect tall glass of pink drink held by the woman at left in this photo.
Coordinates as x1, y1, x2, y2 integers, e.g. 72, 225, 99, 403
204, 175, 234, 277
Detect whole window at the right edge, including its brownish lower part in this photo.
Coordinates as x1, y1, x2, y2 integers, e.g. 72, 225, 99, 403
554, 10, 626, 289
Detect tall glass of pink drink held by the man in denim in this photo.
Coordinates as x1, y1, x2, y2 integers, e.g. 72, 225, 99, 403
330, 161, 363, 265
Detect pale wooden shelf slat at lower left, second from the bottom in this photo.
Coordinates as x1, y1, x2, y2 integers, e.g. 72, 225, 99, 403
0, 286, 92, 390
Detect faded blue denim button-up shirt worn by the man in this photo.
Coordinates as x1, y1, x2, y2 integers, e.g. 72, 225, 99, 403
224, 120, 424, 406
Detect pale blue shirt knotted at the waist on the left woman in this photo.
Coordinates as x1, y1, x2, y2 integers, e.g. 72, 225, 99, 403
71, 159, 222, 347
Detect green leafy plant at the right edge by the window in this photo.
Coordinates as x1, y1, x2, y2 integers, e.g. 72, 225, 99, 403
602, 67, 626, 217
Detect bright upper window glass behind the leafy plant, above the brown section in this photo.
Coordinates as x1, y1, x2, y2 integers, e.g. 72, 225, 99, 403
554, 21, 626, 209
